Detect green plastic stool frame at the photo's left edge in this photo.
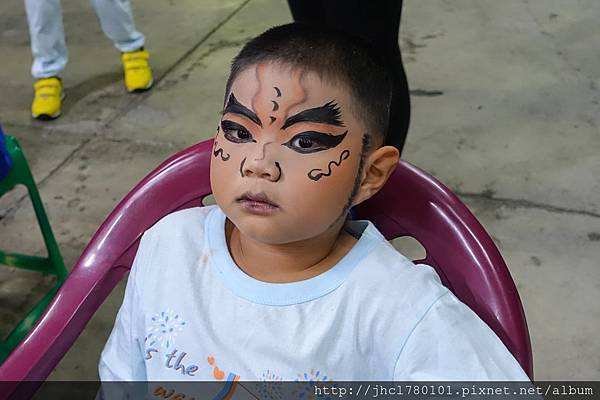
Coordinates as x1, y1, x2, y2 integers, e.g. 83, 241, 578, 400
0, 134, 68, 363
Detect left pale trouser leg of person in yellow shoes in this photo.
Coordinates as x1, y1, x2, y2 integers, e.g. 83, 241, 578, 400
25, 0, 69, 79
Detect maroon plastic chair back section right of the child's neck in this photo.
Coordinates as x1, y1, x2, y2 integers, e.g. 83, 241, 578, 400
353, 161, 533, 380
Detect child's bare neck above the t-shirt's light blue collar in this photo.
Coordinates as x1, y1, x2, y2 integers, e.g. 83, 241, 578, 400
225, 219, 356, 283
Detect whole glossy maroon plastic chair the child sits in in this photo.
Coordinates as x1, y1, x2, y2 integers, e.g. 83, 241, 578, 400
0, 140, 533, 398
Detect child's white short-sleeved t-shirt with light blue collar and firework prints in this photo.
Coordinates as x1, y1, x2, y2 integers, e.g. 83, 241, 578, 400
99, 206, 527, 382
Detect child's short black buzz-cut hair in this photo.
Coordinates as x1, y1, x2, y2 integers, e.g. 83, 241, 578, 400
225, 23, 392, 144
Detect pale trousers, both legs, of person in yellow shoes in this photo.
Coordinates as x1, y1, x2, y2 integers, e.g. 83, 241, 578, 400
25, 0, 144, 79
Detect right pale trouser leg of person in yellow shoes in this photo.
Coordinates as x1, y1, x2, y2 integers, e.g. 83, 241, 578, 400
90, 0, 145, 53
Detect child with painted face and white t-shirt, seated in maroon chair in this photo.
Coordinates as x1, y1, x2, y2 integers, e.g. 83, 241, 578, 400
100, 24, 527, 388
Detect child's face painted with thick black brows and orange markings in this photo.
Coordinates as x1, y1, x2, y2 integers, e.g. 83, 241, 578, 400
210, 63, 366, 244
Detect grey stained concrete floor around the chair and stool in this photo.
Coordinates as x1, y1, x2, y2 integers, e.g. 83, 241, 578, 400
0, 0, 600, 380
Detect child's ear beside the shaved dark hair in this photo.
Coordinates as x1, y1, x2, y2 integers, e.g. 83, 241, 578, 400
352, 146, 400, 206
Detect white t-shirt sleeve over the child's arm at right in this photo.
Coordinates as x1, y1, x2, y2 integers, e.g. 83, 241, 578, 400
394, 292, 529, 381
